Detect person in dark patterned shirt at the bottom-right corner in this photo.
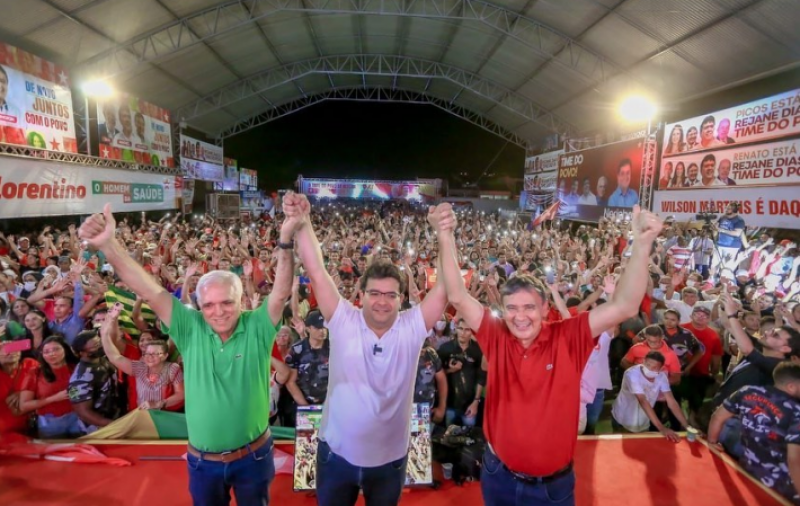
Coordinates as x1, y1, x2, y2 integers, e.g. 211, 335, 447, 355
708, 362, 800, 504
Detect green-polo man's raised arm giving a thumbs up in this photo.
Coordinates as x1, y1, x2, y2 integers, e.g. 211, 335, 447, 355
79, 204, 174, 326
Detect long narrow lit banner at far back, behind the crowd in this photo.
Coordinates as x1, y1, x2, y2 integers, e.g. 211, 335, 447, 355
300, 178, 436, 201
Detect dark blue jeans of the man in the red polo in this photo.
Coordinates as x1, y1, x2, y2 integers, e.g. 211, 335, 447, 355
481, 447, 575, 506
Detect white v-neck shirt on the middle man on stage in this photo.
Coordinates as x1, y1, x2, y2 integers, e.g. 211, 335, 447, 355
320, 299, 428, 467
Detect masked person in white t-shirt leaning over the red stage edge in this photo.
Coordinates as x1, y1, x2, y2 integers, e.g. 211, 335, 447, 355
611, 351, 688, 443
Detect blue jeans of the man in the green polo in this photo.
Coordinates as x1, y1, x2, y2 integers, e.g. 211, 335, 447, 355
186, 436, 275, 506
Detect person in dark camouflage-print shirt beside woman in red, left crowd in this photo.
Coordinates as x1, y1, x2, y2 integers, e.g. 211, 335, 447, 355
68, 330, 121, 434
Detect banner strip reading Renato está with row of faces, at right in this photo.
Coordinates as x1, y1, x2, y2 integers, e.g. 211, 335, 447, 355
658, 139, 800, 191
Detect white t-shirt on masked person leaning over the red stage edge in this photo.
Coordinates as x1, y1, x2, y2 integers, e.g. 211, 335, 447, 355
611, 365, 670, 432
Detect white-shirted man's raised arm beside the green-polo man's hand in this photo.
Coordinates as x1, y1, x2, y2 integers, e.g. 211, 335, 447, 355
283, 194, 341, 320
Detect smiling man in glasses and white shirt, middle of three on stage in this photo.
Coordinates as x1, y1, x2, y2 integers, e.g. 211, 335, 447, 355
288, 196, 447, 506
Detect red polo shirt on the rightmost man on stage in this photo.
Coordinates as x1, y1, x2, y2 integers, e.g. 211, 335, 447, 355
476, 309, 595, 476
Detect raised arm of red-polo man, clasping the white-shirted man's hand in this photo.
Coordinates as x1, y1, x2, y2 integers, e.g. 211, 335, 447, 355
428, 203, 483, 332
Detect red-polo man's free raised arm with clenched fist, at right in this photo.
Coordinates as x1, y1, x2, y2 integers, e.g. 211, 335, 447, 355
589, 206, 663, 336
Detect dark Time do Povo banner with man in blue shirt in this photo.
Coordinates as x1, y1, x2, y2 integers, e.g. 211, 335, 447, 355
555, 139, 645, 221
